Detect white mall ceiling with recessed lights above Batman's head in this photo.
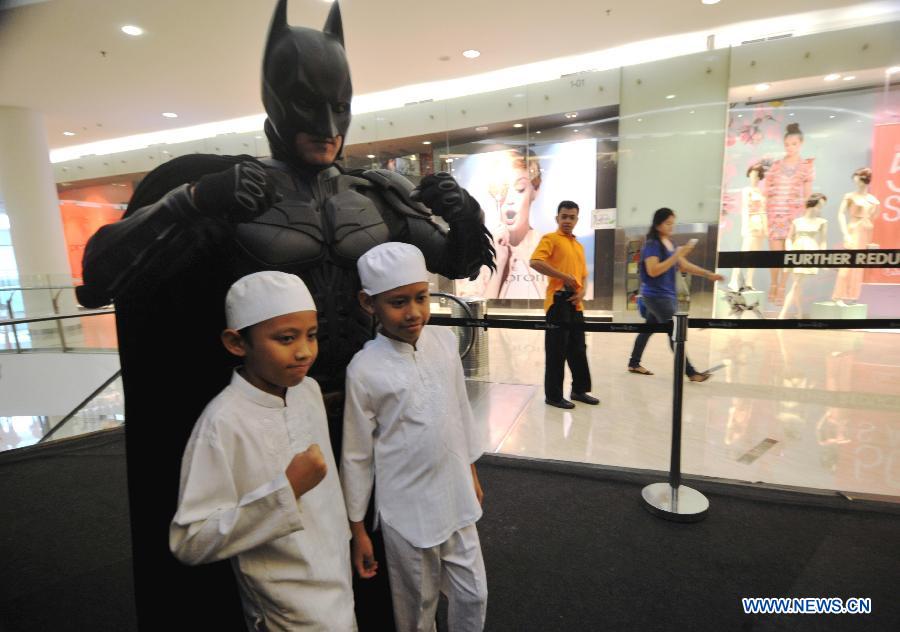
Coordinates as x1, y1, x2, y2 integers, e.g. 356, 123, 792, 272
0, 0, 888, 150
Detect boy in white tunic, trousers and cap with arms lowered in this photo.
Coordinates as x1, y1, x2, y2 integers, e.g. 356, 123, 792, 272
341, 242, 487, 632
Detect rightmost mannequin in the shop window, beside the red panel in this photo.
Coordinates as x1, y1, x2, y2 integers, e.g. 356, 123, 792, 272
831, 167, 881, 306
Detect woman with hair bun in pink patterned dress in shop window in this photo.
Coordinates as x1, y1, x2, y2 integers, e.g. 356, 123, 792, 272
766, 123, 816, 303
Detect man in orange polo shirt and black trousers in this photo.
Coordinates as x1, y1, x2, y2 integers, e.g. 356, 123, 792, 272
530, 200, 600, 409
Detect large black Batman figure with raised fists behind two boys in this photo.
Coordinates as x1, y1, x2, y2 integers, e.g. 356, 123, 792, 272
77, 0, 493, 631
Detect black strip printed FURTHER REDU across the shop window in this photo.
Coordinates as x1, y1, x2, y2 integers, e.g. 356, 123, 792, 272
717, 248, 900, 268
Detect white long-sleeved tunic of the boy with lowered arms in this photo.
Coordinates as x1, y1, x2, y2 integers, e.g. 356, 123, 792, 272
341, 326, 485, 548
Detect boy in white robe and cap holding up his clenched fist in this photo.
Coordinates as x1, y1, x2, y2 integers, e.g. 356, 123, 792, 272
169, 271, 356, 632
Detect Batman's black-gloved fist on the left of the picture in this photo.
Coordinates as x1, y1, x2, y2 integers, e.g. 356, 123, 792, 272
193, 160, 281, 223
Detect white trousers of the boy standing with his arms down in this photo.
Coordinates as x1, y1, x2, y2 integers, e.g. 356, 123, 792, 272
381, 521, 487, 632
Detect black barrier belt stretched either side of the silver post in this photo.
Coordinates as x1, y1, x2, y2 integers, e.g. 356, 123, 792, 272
428, 314, 900, 334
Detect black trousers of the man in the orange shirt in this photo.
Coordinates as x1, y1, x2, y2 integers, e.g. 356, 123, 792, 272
544, 301, 591, 402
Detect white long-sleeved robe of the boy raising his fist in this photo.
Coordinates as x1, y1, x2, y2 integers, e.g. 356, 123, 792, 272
169, 372, 356, 632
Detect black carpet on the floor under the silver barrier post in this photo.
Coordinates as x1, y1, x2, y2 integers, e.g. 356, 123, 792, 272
0, 430, 900, 632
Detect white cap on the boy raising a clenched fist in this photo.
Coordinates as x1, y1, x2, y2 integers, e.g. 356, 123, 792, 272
225, 270, 316, 329
